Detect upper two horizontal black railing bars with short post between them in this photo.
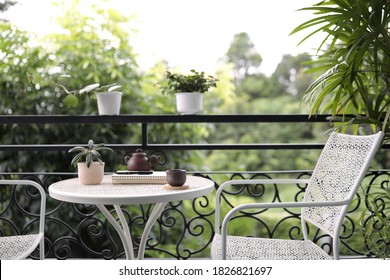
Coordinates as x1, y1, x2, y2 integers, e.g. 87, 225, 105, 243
0, 114, 378, 151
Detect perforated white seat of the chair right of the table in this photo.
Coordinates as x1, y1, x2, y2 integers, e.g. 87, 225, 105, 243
211, 234, 332, 260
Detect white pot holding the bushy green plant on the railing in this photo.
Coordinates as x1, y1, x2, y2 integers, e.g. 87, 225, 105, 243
176, 92, 203, 115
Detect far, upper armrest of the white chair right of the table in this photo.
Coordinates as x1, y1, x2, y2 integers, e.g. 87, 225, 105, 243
215, 179, 310, 233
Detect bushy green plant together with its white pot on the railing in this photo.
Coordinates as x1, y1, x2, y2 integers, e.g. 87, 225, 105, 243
161, 70, 218, 115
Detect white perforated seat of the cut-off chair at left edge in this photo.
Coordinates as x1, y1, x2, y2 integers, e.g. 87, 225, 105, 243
0, 234, 43, 260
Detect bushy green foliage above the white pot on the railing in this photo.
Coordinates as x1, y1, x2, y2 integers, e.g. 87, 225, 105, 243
161, 70, 218, 94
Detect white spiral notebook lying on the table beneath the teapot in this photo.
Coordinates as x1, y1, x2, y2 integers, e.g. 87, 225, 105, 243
112, 171, 167, 184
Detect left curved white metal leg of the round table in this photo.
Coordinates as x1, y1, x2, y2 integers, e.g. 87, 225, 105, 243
96, 205, 134, 260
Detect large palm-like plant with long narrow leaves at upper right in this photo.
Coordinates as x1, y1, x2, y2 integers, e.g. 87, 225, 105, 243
292, 0, 390, 140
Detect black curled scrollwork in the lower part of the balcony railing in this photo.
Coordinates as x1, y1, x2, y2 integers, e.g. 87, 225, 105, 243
0, 172, 389, 259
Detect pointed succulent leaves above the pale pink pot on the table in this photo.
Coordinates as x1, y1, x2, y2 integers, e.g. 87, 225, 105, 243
68, 139, 113, 168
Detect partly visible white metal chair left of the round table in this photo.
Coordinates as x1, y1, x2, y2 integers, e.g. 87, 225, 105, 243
0, 180, 46, 260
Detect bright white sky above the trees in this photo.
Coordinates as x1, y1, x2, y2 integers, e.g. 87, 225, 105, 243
4, 0, 319, 75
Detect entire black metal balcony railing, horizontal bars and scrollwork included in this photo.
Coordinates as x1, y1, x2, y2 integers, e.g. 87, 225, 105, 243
0, 115, 389, 259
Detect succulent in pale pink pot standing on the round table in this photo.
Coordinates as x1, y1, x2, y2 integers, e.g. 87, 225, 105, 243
68, 140, 113, 185
